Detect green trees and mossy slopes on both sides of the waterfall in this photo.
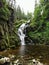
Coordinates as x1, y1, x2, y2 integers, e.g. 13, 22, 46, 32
0, 0, 49, 49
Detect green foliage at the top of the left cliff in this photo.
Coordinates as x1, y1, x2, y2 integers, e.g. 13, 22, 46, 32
0, 0, 10, 20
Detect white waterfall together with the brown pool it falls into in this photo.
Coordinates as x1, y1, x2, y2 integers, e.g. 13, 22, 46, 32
0, 21, 49, 65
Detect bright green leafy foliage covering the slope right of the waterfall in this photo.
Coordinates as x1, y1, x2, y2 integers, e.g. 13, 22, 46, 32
28, 0, 49, 44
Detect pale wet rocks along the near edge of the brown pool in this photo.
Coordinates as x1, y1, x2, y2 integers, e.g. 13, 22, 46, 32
0, 55, 46, 65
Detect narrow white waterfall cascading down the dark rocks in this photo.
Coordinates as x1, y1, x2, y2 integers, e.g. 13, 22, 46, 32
18, 20, 30, 45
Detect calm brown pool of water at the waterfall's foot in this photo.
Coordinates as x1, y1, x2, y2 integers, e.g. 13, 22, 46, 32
0, 45, 49, 65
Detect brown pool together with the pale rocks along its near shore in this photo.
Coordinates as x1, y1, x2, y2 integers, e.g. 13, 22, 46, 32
0, 45, 49, 65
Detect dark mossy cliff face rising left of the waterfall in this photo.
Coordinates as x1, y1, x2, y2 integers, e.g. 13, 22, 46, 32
0, 0, 18, 49
